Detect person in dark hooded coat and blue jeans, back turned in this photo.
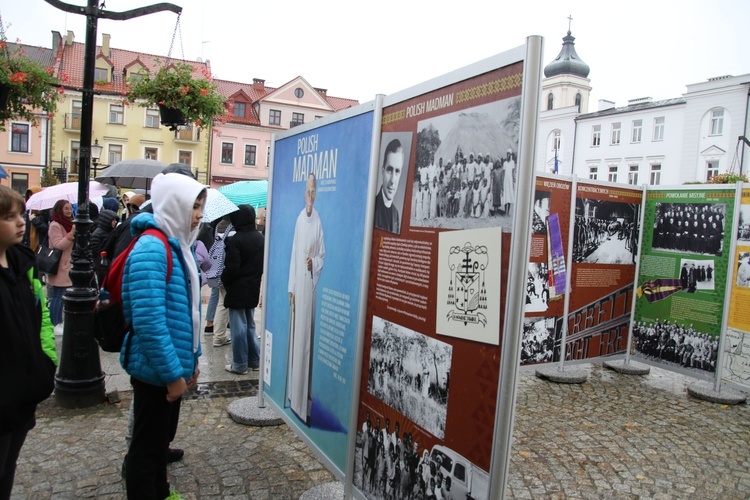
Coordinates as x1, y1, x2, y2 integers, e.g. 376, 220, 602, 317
221, 205, 264, 375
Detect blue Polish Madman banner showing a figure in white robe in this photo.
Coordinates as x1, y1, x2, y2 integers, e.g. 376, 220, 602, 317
263, 111, 373, 473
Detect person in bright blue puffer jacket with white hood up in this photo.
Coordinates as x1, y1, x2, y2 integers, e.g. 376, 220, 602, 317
120, 174, 206, 499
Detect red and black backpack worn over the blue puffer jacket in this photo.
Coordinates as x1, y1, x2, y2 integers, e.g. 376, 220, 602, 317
94, 229, 172, 352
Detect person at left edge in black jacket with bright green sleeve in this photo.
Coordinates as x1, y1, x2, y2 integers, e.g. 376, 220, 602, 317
0, 186, 57, 500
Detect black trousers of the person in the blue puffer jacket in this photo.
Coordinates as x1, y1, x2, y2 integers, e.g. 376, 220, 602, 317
125, 377, 182, 500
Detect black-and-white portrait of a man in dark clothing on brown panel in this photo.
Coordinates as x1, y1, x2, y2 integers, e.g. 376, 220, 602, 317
373, 132, 413, 234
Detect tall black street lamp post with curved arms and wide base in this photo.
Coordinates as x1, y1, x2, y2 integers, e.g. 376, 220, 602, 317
45, 0, 182, 408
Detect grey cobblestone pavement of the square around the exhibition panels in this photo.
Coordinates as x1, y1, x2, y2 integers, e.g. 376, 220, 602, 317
12, 364, 750, 500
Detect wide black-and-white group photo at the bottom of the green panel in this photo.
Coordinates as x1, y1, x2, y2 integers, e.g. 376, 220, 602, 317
633, 319, 719, 372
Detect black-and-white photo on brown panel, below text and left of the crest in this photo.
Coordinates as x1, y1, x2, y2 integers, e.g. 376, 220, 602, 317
367, 316, 453, 439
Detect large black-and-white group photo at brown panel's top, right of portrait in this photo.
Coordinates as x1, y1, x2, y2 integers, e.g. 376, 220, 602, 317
410, 97, 521, 229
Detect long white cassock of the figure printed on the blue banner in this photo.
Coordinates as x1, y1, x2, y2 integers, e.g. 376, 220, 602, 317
287, 208, 326, 421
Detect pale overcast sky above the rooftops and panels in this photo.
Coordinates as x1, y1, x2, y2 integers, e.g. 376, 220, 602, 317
0, 0, 750, 107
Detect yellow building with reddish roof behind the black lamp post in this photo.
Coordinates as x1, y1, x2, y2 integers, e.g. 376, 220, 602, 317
50, 31, 211, 184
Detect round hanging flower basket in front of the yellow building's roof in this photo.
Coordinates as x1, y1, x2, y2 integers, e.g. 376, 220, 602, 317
127, 63, 226, 130
